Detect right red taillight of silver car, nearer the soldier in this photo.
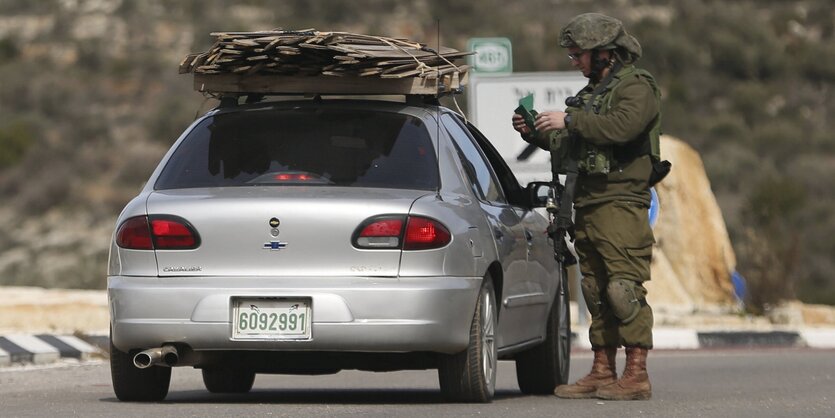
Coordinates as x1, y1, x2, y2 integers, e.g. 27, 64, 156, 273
353, 215, 452, 250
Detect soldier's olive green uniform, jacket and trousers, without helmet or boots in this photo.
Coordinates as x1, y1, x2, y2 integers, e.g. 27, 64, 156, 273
526, 65, 660, 348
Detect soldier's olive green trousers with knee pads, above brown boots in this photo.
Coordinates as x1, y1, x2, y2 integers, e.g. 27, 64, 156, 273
574, 201, 655, 348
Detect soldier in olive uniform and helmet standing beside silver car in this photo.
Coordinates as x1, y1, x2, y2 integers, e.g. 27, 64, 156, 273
513, 13, 668, 400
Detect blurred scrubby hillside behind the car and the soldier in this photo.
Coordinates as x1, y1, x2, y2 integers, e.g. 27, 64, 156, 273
0, 0, 835, 314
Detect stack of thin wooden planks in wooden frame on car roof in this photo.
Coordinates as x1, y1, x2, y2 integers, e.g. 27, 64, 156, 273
180, 29, 471, 97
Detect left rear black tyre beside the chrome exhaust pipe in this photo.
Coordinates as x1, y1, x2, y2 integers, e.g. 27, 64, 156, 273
110, 334, 171, 402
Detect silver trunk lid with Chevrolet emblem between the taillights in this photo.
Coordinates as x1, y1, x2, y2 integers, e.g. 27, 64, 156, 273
147, 186, 430, 276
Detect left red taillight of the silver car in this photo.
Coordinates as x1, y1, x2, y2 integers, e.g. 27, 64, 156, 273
116, 215, 200, 250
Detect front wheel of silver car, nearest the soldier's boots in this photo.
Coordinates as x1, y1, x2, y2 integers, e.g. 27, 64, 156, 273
516, 267, 571, 394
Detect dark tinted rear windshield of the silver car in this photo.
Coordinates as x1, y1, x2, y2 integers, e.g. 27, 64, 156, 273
155, 109, 438, 190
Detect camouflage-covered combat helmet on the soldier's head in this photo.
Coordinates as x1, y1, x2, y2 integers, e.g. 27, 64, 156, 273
560, 13, 641, 64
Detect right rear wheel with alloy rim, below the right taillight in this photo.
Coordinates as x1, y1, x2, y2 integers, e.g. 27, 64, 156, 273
438, 275, 498, 402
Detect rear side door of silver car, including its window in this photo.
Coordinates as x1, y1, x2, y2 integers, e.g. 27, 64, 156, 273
441, 113, 538, 348
